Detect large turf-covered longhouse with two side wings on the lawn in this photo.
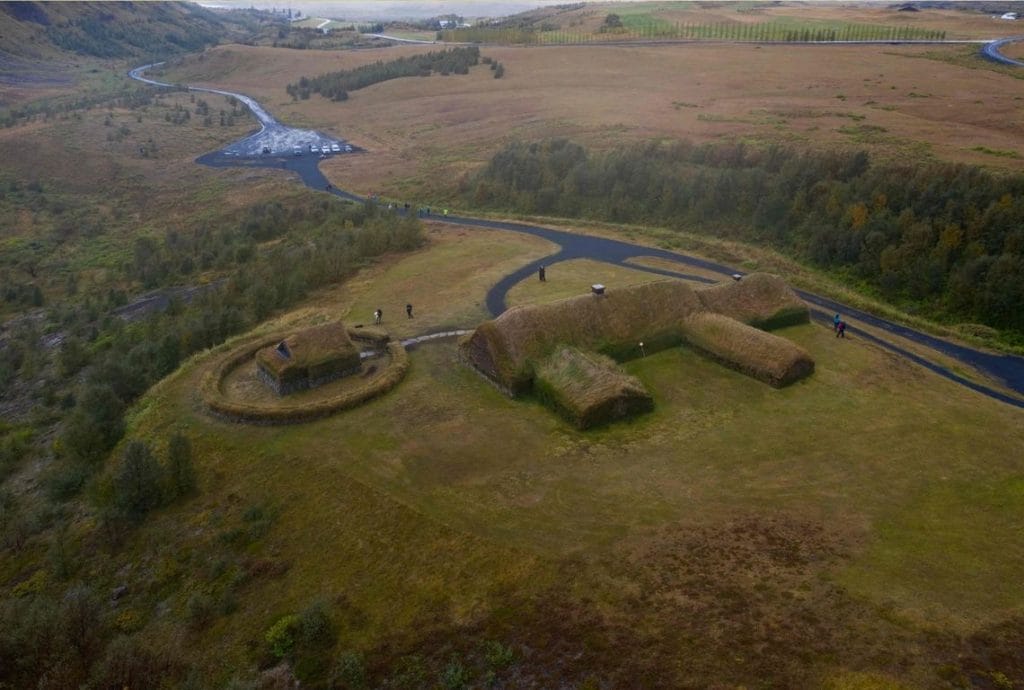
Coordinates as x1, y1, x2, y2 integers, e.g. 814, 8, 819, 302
460, 273, 814, 426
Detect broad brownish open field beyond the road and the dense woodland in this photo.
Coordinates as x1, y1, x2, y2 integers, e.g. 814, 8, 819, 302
159, 36, 1024, 203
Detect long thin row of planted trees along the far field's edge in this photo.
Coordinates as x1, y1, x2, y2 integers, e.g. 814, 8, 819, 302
437, 20, 946, 44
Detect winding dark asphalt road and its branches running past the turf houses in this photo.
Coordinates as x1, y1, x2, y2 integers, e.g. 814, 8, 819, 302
129, 37, 1024, 408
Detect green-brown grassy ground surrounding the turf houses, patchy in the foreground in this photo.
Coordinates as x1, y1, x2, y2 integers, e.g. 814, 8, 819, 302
112, 223, 1024, 687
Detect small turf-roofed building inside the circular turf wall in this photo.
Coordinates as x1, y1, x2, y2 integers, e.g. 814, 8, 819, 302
256, 322, 359, 395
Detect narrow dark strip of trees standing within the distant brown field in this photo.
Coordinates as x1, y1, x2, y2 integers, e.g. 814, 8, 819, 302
285, 46, 480, 100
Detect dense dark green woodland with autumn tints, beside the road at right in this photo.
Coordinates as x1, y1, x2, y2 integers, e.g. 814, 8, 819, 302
463, 139, 1024, 344
